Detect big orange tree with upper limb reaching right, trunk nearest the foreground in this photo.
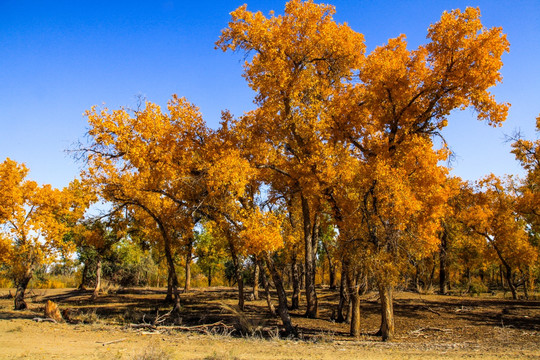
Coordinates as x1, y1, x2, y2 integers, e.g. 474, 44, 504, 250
327, 8, 508, 340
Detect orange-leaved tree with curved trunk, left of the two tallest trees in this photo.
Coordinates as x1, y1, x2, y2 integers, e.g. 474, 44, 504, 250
79, 96, 209, 309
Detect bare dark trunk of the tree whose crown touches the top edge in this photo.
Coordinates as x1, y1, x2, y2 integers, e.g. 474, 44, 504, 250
301, 195, 318, 318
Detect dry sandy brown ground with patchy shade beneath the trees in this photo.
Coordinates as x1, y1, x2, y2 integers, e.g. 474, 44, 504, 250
0, 288, 540, 360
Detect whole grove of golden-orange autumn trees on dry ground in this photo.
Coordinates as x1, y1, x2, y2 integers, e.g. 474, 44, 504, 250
0, 0, 540, 340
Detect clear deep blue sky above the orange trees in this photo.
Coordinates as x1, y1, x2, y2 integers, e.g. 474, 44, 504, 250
0, 0, 540, 187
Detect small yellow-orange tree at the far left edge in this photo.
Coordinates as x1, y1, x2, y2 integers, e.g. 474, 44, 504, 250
0, 158, 90, 310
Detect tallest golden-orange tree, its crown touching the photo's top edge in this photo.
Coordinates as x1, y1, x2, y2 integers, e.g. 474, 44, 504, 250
217, 0, 364, 317
